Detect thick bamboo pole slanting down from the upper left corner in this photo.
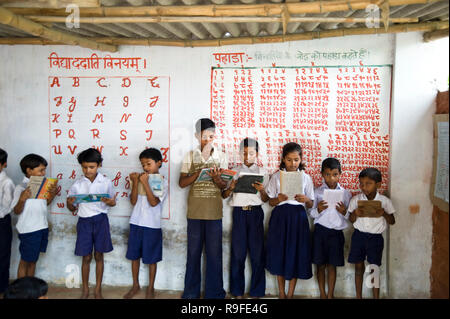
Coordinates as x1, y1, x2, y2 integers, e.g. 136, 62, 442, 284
0, 7, 117, 52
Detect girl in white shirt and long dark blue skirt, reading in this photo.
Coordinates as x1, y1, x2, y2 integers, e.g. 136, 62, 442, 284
266, 142, 314, 299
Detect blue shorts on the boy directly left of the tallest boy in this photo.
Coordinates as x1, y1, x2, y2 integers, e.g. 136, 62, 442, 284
126, 224, 162, 264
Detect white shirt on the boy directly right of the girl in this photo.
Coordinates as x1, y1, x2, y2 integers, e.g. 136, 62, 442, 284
309, 181, 352, 230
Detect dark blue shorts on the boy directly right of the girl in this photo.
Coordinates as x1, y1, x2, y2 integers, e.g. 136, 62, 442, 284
312, 224, 345, 267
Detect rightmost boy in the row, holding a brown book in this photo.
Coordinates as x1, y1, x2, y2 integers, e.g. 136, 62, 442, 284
348, 167, 395, 299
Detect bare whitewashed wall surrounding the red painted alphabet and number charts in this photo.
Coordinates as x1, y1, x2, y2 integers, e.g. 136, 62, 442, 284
0, 33, 448, 297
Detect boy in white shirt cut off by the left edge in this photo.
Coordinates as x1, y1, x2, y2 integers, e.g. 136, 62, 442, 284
0, 148, 15, 294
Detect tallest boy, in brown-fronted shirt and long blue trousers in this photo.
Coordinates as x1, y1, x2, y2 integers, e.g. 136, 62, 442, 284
178, 118, 228, 299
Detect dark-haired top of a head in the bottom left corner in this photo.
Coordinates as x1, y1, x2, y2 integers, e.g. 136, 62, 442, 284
3, 277, 48, 299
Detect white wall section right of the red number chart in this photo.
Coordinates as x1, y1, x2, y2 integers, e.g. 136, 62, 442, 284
389, 33, 449, 298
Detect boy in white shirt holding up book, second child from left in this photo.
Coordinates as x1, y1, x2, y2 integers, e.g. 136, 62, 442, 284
11, 154, 56, 278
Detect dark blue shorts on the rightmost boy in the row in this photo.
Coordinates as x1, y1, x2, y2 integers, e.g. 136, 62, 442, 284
348, 229, 384, 266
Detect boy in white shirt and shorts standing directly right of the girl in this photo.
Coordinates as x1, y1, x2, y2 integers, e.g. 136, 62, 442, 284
310, 158, 352, 299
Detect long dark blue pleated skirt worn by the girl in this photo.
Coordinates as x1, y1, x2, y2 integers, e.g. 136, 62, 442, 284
266, 204, 312, 280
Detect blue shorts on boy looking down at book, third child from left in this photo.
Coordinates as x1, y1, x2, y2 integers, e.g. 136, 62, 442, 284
75, 213, 113, 256
